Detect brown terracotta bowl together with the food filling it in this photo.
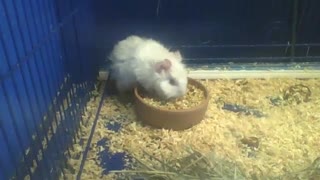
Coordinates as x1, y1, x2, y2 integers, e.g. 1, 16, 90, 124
134, 78, 210, 130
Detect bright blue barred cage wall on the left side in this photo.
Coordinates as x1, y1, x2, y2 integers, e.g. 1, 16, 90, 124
0, 0, 96, 179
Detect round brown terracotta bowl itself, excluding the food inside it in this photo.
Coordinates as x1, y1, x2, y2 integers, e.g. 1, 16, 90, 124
134, 78, 209, 130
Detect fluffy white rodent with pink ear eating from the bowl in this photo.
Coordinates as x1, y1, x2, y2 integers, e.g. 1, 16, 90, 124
109, 35, 188, 99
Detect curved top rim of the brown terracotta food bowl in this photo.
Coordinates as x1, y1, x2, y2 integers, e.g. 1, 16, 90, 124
134, 77, 210, 113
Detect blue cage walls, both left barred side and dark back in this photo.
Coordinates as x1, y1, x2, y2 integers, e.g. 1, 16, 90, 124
0, 0, 320, 179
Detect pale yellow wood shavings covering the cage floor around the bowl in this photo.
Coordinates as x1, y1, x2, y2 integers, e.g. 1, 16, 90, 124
61, 79, 320, 179
